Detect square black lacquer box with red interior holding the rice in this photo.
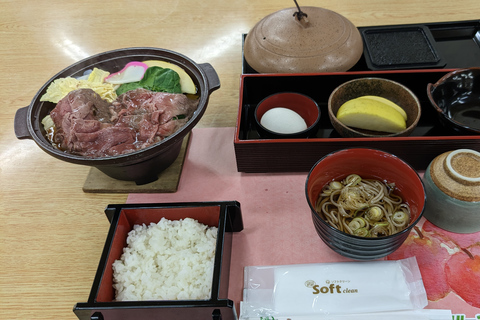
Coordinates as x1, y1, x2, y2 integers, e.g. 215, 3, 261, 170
73, 201, 243, 320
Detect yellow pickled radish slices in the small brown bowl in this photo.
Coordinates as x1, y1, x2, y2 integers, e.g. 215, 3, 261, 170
337, 97, 407, 133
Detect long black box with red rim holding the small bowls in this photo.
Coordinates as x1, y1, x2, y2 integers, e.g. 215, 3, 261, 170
234, 69, 480, 173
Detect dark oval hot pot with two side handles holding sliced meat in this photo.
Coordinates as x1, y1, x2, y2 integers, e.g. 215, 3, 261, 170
15, 48, 220, 184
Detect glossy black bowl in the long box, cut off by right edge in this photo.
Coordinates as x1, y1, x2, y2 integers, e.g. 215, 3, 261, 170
427, 67, 480, 135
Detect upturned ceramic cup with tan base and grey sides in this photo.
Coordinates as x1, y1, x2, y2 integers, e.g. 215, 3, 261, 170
423, 149, 480, 233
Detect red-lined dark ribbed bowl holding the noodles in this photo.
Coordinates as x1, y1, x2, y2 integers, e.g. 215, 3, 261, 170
305, 148, 426, 260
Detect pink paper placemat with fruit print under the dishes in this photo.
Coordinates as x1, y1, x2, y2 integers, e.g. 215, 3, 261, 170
127, 128, 480, 318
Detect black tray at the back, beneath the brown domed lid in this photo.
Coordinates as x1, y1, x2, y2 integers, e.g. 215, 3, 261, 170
242, 20, 480, 74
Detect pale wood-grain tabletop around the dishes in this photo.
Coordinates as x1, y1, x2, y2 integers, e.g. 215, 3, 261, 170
0, 0, 480, 320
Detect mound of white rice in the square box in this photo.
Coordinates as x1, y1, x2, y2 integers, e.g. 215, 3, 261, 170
112, 218, 217, 301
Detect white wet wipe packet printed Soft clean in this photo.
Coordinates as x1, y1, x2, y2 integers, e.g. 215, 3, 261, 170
240, 257, 428, 318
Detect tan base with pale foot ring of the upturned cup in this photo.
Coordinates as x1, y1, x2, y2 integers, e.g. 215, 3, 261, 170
430, 149, 480, 202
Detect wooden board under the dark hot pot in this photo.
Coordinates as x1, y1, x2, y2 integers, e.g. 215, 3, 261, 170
83, 132, 191, 193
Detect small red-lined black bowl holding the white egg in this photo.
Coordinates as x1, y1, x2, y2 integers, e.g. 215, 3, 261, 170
254, 92, 321, 139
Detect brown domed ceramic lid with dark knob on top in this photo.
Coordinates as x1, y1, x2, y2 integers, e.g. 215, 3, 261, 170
244, 7, 363, 73
